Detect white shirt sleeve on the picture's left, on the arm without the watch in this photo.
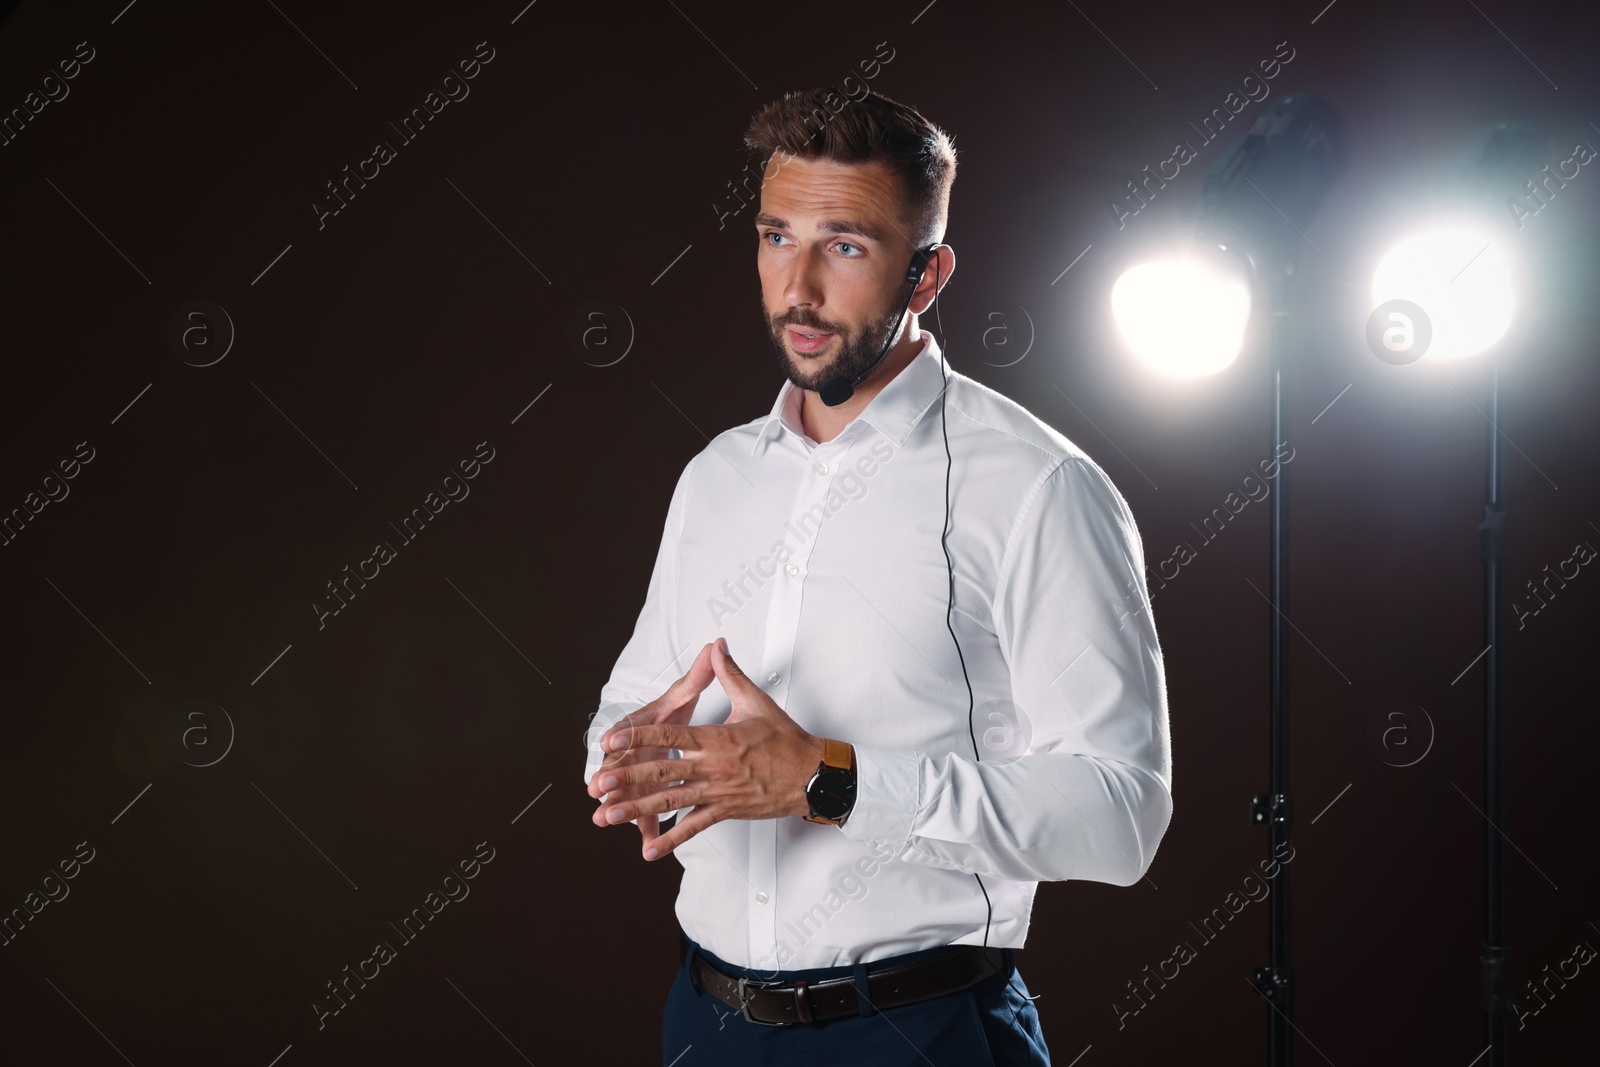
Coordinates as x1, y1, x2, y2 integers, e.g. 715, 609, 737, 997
584, 454, 699, 793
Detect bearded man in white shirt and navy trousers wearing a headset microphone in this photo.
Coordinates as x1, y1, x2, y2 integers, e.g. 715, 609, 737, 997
584, 91, 1171, 1067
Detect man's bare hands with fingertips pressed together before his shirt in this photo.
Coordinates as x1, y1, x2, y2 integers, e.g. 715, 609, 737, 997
589, 637, 822, 859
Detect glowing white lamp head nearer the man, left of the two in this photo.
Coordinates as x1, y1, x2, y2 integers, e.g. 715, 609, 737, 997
1110, 254, 1250, 378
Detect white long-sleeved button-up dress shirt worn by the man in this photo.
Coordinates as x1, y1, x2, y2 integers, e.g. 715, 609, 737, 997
584, 333, 1171, 971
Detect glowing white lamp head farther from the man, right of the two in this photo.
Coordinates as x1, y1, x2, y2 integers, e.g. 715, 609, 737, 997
1373, 222, 1515, 362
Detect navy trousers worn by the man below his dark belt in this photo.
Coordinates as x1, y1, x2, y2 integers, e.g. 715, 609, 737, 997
661, 933, 1050, 1067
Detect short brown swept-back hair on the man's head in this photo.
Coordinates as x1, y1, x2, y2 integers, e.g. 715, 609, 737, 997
744, 88, 955, 248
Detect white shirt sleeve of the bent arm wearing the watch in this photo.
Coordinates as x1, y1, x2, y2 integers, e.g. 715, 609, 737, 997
840, 456, 1173, 885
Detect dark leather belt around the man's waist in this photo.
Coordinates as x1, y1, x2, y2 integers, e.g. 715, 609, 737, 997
685, 945, 1006, 1025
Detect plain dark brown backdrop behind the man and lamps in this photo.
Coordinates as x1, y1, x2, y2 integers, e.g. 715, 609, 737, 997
0, 0, 1600, 1067
